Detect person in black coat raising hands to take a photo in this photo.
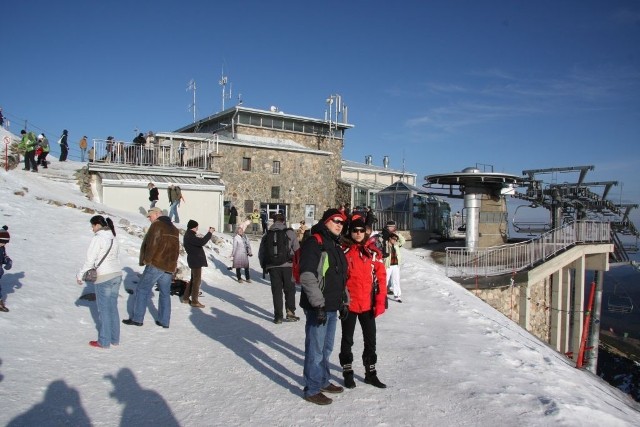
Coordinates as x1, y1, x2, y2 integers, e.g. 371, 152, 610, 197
182, 219, 216, 308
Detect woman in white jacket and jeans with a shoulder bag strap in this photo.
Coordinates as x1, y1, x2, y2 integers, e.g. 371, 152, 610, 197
76, 215, 122, 348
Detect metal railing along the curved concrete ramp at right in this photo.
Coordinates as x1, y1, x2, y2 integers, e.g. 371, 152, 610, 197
446, 221, 610, 277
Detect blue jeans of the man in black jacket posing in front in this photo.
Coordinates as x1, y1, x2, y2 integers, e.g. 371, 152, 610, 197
303, 309, 338, 397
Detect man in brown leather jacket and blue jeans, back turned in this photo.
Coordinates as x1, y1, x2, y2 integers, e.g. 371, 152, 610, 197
122, 208, 180, 328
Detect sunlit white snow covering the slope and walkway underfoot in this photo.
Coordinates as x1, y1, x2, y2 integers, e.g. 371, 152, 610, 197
0, 150, 640, 426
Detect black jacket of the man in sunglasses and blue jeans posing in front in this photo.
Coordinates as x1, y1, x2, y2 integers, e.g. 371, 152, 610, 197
300, 223, 347, 311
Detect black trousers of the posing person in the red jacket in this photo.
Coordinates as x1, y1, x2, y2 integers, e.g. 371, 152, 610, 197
340, 310, 378, 367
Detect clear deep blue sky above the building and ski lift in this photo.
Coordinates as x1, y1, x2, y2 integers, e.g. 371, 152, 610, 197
0, 0, 640, 224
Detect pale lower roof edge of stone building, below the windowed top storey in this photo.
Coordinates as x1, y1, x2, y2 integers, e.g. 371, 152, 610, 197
156, 132, 333, 156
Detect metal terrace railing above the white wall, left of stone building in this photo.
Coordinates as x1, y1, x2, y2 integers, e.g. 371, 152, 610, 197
89, 139, 218, 170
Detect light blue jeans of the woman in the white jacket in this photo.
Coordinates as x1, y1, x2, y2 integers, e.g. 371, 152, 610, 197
95, 276, 122, 348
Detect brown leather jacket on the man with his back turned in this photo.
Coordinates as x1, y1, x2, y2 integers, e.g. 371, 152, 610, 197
140, 216, 180, 273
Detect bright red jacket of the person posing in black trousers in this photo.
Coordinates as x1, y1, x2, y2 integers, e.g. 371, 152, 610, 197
343, 242, 387, 317
